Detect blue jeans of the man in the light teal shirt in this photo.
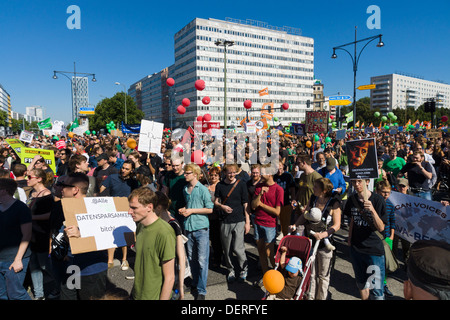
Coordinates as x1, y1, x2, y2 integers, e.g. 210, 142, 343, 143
186, 228, 209, 295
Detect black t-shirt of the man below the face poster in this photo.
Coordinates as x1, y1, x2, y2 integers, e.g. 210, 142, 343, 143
344, 192, 388, 256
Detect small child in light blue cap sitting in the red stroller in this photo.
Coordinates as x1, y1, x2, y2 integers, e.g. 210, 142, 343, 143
267, 246, 303, 300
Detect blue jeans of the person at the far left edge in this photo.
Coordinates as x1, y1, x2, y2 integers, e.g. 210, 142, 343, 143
0, 258, 31, 300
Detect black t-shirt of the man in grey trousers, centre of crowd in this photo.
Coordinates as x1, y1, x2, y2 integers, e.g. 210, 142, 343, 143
214, 180, 248, 223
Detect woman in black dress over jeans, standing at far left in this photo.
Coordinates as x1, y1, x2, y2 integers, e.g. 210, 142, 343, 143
27, 168, 53, 300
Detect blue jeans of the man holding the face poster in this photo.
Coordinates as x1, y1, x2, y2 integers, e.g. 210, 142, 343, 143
350, 246, 385, 300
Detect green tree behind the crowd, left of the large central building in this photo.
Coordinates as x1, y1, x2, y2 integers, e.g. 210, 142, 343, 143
89, 92, 144, 131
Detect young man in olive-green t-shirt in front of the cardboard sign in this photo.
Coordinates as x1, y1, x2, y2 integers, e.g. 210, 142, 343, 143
128, 187, 176, 300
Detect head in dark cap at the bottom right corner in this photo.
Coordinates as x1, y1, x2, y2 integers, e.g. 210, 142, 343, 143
403, 240, 450, 300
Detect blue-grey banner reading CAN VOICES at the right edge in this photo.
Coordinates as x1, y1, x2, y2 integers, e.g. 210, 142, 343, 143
389, 192, 450, 243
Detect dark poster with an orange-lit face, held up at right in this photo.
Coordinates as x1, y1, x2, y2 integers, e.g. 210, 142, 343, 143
346, 139, 378, 179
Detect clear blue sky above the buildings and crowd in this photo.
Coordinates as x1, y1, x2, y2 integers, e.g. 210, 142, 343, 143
0, 0, 450, 122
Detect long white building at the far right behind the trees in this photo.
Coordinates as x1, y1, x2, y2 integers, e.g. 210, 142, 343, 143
370, 73, 450, 114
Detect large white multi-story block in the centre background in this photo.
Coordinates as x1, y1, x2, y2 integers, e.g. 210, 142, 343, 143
129, 18, 314, 126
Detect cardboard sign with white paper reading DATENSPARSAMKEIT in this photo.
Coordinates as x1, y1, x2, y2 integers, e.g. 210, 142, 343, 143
61, 197, 136, 254
